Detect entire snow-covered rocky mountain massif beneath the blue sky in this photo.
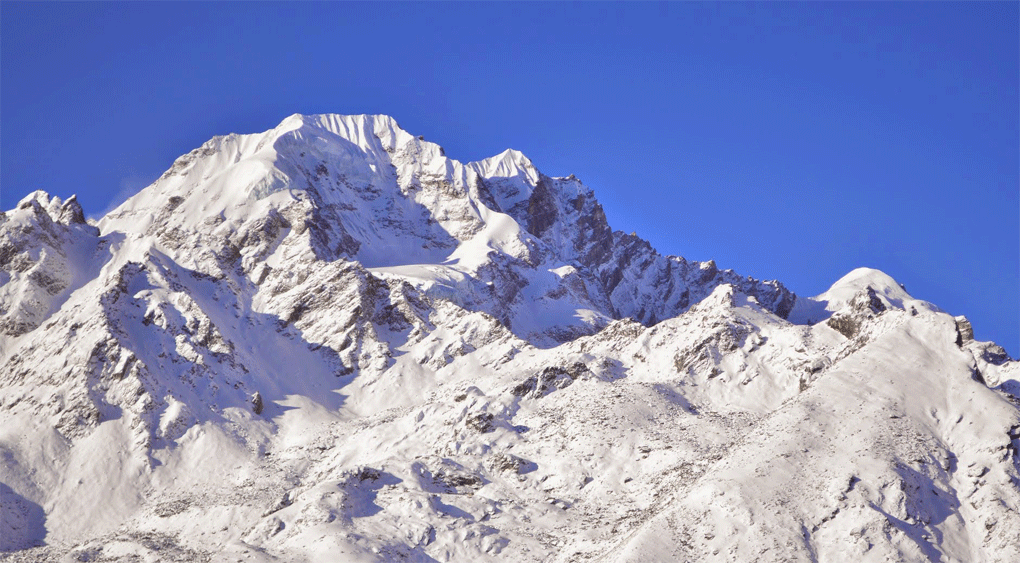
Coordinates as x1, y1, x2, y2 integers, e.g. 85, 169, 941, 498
0, 115, 1020, 562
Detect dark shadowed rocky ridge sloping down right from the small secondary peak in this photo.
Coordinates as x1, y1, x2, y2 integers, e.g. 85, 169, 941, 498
469, 144, 796, 324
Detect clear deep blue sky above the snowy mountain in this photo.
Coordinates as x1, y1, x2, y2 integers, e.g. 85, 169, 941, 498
0, 2, 1020, 356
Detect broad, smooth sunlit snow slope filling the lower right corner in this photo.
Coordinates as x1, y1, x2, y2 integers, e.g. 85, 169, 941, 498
607, 315, 1020, 561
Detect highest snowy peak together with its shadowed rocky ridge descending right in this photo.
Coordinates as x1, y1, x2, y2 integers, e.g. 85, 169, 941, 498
100, 115, 795, 344
